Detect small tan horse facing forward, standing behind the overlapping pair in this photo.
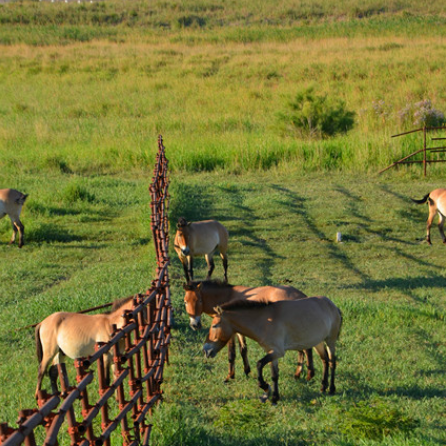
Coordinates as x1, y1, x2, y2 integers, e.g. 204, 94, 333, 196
174, 218, 229, 282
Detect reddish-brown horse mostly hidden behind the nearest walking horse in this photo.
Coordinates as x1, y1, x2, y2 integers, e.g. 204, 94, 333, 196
183, 281, 314, 382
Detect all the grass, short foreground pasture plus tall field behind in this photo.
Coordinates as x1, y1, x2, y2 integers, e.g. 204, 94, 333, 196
0, 0, 446, 446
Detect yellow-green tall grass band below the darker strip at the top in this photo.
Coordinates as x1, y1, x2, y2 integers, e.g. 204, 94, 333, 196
0, 27, 446, 175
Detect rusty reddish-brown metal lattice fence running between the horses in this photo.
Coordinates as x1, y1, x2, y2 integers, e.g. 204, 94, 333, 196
0, 136, 172, 446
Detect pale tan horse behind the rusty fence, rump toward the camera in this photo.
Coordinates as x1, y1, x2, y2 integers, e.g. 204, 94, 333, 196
36, 297, 133, 397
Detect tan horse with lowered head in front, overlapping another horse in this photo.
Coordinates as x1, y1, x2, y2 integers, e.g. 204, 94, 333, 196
203, 297, 342, 404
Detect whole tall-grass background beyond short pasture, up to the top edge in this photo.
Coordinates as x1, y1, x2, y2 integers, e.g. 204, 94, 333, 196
0, 2, 446, 175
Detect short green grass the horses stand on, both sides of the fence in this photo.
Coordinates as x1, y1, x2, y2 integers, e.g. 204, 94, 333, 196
0, 172, 446, 445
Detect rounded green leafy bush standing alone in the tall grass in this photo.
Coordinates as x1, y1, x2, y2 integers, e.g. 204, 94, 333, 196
279, 88, 355, 138
